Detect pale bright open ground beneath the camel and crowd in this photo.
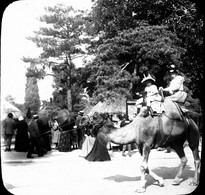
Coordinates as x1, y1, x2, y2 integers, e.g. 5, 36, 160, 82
2, 144, 201, 195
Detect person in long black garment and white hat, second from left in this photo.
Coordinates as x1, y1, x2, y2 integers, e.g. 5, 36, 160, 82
15, 116, 29, 152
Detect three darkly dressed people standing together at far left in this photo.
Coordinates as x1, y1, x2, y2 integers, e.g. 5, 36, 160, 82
2, 113, 51, 158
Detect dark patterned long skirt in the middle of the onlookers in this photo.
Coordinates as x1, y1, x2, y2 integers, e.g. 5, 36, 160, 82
58, 131, 71, 152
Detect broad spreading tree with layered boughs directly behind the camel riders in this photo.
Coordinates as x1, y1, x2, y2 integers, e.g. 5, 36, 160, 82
84, 23, 185, 101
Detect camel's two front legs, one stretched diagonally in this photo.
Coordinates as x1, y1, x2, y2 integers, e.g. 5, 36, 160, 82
137, 145, 164, 193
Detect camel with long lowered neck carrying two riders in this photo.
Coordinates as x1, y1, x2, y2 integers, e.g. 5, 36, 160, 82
91, 98, 200, 193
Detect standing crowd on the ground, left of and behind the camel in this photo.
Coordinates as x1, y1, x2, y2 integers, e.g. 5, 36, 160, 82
3, 111, 135, 161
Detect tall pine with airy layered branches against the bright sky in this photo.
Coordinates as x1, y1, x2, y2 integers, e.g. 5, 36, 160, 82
24, 4, 87, 111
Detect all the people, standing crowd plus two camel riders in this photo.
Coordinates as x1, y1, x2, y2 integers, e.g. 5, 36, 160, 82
3, 64, 187, 161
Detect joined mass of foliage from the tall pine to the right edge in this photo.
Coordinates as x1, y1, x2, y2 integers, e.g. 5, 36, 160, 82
24, 0, 203, 111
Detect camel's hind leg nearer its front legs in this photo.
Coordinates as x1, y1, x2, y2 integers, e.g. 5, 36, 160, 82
172, 145, 187, 185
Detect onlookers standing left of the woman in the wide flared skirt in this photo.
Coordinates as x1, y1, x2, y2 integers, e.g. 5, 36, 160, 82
2, 111, 91, 158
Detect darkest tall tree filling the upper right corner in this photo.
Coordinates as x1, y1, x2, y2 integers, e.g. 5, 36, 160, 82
91, 0, 203, 99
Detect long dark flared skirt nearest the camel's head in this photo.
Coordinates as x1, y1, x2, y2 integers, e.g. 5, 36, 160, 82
85, 132, 111, 161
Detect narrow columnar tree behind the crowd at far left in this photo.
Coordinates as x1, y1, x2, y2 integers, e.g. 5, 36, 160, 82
24, 70, 40, 113
